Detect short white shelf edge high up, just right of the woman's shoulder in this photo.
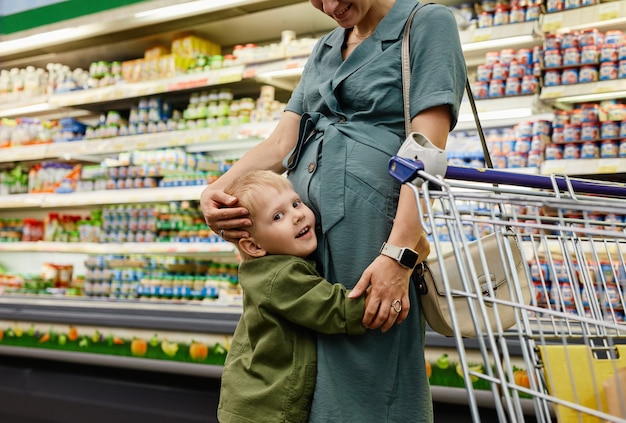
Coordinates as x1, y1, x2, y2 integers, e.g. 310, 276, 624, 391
459, 21, 543, 67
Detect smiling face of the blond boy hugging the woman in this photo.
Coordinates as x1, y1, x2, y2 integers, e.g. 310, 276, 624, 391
246, 188, 317, 257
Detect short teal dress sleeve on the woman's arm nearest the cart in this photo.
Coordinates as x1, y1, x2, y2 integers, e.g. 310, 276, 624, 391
410, 4, 467, 130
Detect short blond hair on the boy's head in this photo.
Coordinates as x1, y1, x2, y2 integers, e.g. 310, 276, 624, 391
224, 170, 293, 225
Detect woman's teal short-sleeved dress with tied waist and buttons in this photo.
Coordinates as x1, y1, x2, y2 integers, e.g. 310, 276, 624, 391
287, 0, 466, 423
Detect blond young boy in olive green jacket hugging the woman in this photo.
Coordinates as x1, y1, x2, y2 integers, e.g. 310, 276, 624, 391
217, 171, 366, 423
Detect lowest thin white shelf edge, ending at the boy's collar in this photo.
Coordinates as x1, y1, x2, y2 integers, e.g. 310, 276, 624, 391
0, 241, 237, 259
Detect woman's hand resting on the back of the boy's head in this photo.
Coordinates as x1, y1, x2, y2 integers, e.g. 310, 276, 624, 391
200, 185, 252, 242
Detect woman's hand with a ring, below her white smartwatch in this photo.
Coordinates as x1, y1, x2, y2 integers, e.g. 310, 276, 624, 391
350, 256, 412, 332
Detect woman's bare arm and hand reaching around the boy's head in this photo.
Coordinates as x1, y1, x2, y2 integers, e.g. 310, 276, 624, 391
200, 111, 300, 240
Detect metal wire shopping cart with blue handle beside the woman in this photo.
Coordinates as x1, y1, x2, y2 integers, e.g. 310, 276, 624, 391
389, 157, 626, 423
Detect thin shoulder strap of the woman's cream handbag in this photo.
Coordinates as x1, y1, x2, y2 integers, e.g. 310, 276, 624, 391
402, 3, 493, 168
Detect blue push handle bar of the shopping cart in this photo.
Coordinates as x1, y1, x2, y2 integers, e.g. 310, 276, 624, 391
388, 156, 626, 198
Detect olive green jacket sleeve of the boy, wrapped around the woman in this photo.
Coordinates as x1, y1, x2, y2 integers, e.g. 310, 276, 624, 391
268, 261, 366, 335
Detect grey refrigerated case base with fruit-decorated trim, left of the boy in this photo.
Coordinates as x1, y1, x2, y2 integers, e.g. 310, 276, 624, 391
0, 296, 241, 377
